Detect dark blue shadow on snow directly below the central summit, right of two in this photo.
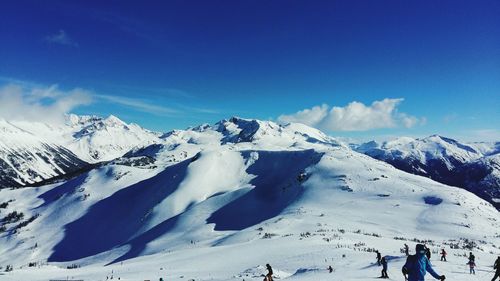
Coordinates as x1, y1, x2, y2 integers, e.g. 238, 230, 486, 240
207, 150, 323, 230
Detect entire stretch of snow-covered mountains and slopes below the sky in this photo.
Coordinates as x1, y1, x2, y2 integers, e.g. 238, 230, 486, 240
0, 115, 500, 280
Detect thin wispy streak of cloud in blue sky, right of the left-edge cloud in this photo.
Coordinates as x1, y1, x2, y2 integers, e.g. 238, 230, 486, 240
94, 95, 180, 117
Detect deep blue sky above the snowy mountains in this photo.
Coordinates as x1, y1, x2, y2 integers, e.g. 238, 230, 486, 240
0, 1, 500, 140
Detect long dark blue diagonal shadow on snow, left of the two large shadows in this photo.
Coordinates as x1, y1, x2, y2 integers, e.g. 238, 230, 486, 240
48, 159, 191, 262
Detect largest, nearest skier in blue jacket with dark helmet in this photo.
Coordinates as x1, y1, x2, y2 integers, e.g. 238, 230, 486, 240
402, 244, 446, 281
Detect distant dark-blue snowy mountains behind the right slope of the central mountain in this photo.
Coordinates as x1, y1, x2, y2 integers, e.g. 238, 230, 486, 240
354, 135, 500, 208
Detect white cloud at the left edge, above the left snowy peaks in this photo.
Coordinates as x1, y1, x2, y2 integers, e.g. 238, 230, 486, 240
0, 84, 92, 123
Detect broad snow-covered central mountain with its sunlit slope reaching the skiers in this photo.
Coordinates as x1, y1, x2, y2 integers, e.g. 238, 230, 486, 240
0, 119, 500, 280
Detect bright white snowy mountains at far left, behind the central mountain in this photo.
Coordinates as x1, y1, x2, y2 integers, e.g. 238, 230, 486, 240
0, 115, 160, 188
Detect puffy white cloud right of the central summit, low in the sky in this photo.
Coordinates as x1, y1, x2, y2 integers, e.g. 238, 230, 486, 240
278, 98, 426, 131
